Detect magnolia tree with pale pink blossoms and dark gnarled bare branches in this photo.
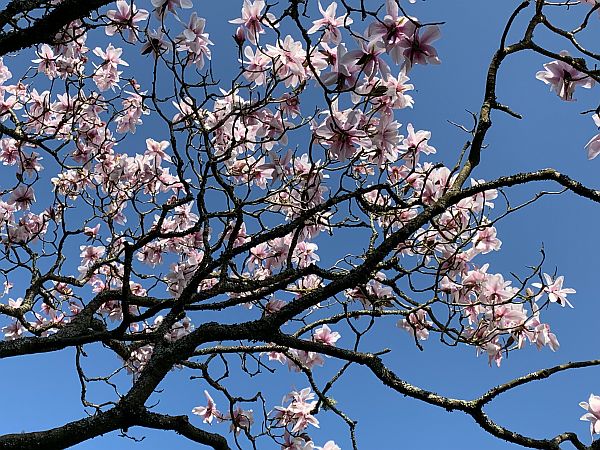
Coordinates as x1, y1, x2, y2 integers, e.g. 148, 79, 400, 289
0, 0, 600, 450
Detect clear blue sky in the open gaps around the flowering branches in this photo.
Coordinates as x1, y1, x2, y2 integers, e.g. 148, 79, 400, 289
0, 0, 600, 450
